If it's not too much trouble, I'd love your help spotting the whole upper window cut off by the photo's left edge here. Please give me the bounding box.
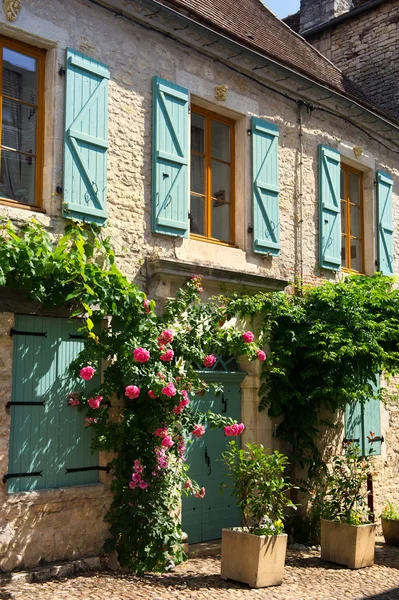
[0,36,45,206]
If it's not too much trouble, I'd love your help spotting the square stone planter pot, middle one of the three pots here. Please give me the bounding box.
[321,519,377,569]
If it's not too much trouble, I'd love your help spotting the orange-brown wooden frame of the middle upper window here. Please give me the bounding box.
[190,104,236,247]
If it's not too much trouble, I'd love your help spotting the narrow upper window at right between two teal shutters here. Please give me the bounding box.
[341,163,364,273]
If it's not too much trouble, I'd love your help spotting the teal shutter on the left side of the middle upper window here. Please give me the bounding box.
[152,77,189,237]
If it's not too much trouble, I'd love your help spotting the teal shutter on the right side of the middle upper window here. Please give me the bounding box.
[252,117,280,256]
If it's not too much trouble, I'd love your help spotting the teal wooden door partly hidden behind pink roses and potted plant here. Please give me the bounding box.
[182,381,241,544]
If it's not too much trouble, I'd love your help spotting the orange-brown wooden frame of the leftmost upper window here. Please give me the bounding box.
[0,35,46,212]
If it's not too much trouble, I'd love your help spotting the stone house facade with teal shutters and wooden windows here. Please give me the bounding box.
[0,0,399,571]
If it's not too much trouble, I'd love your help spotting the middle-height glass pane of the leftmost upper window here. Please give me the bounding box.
[1,99,37,154]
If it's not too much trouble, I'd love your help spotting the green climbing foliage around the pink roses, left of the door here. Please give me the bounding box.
[0,221,264,574]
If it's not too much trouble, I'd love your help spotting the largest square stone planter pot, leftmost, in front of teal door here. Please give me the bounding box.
[221,529,288,588]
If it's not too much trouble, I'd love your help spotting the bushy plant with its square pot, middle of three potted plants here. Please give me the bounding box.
[319,443,377,569]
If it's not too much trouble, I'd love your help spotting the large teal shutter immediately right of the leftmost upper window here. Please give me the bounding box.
[63,48,109,225]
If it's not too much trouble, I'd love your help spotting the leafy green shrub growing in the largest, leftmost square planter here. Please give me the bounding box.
[222,440,295,535]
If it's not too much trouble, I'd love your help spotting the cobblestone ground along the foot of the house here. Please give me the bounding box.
[0,543,399,600]
